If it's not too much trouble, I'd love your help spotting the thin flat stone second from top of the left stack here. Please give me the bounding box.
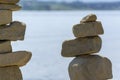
[0,4,21,11]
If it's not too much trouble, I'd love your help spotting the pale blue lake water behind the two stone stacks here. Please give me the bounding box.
[12,11,120,80]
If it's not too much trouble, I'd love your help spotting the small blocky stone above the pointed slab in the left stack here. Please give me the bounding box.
[0,41,12,54]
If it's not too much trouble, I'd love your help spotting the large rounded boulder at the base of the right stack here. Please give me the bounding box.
[69,55,113,80]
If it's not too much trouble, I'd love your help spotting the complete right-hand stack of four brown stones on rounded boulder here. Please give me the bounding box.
[61,14,113,80]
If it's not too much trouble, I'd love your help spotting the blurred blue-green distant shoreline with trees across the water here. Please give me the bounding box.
[20,0,120,10]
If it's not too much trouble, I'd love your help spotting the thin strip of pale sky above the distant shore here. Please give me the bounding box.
[39,0,120,2]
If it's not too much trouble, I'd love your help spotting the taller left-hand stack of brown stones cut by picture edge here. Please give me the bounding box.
[0,0,31,80]
